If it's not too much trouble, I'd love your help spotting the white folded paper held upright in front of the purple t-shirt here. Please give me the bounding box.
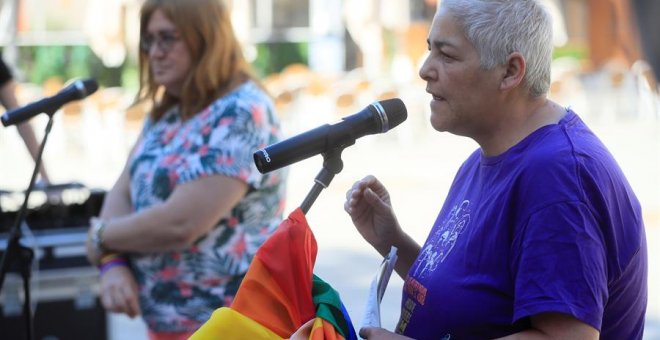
[360,246,397,328]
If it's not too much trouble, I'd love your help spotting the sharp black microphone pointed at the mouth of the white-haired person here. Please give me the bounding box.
[253,98,408,174]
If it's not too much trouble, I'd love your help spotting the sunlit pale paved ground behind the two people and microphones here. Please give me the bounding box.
[0,79,660,339]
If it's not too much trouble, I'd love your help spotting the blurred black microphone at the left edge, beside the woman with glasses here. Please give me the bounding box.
[2,79,99,126]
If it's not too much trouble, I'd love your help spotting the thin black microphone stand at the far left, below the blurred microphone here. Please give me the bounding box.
[0,114,55,340]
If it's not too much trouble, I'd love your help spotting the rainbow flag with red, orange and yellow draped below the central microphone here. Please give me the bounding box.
[190,208,357,340]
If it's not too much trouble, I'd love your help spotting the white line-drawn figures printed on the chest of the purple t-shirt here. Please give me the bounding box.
[413,200,470,278]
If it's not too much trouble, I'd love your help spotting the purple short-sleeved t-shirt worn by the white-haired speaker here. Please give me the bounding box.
[397,110,647,339]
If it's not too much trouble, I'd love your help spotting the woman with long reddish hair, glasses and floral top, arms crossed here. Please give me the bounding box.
[87,0,285,339]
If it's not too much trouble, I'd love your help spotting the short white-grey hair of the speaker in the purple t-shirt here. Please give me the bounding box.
[440,0,553,96]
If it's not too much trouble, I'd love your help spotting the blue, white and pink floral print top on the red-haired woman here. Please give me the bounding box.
[129,81,285,332]
